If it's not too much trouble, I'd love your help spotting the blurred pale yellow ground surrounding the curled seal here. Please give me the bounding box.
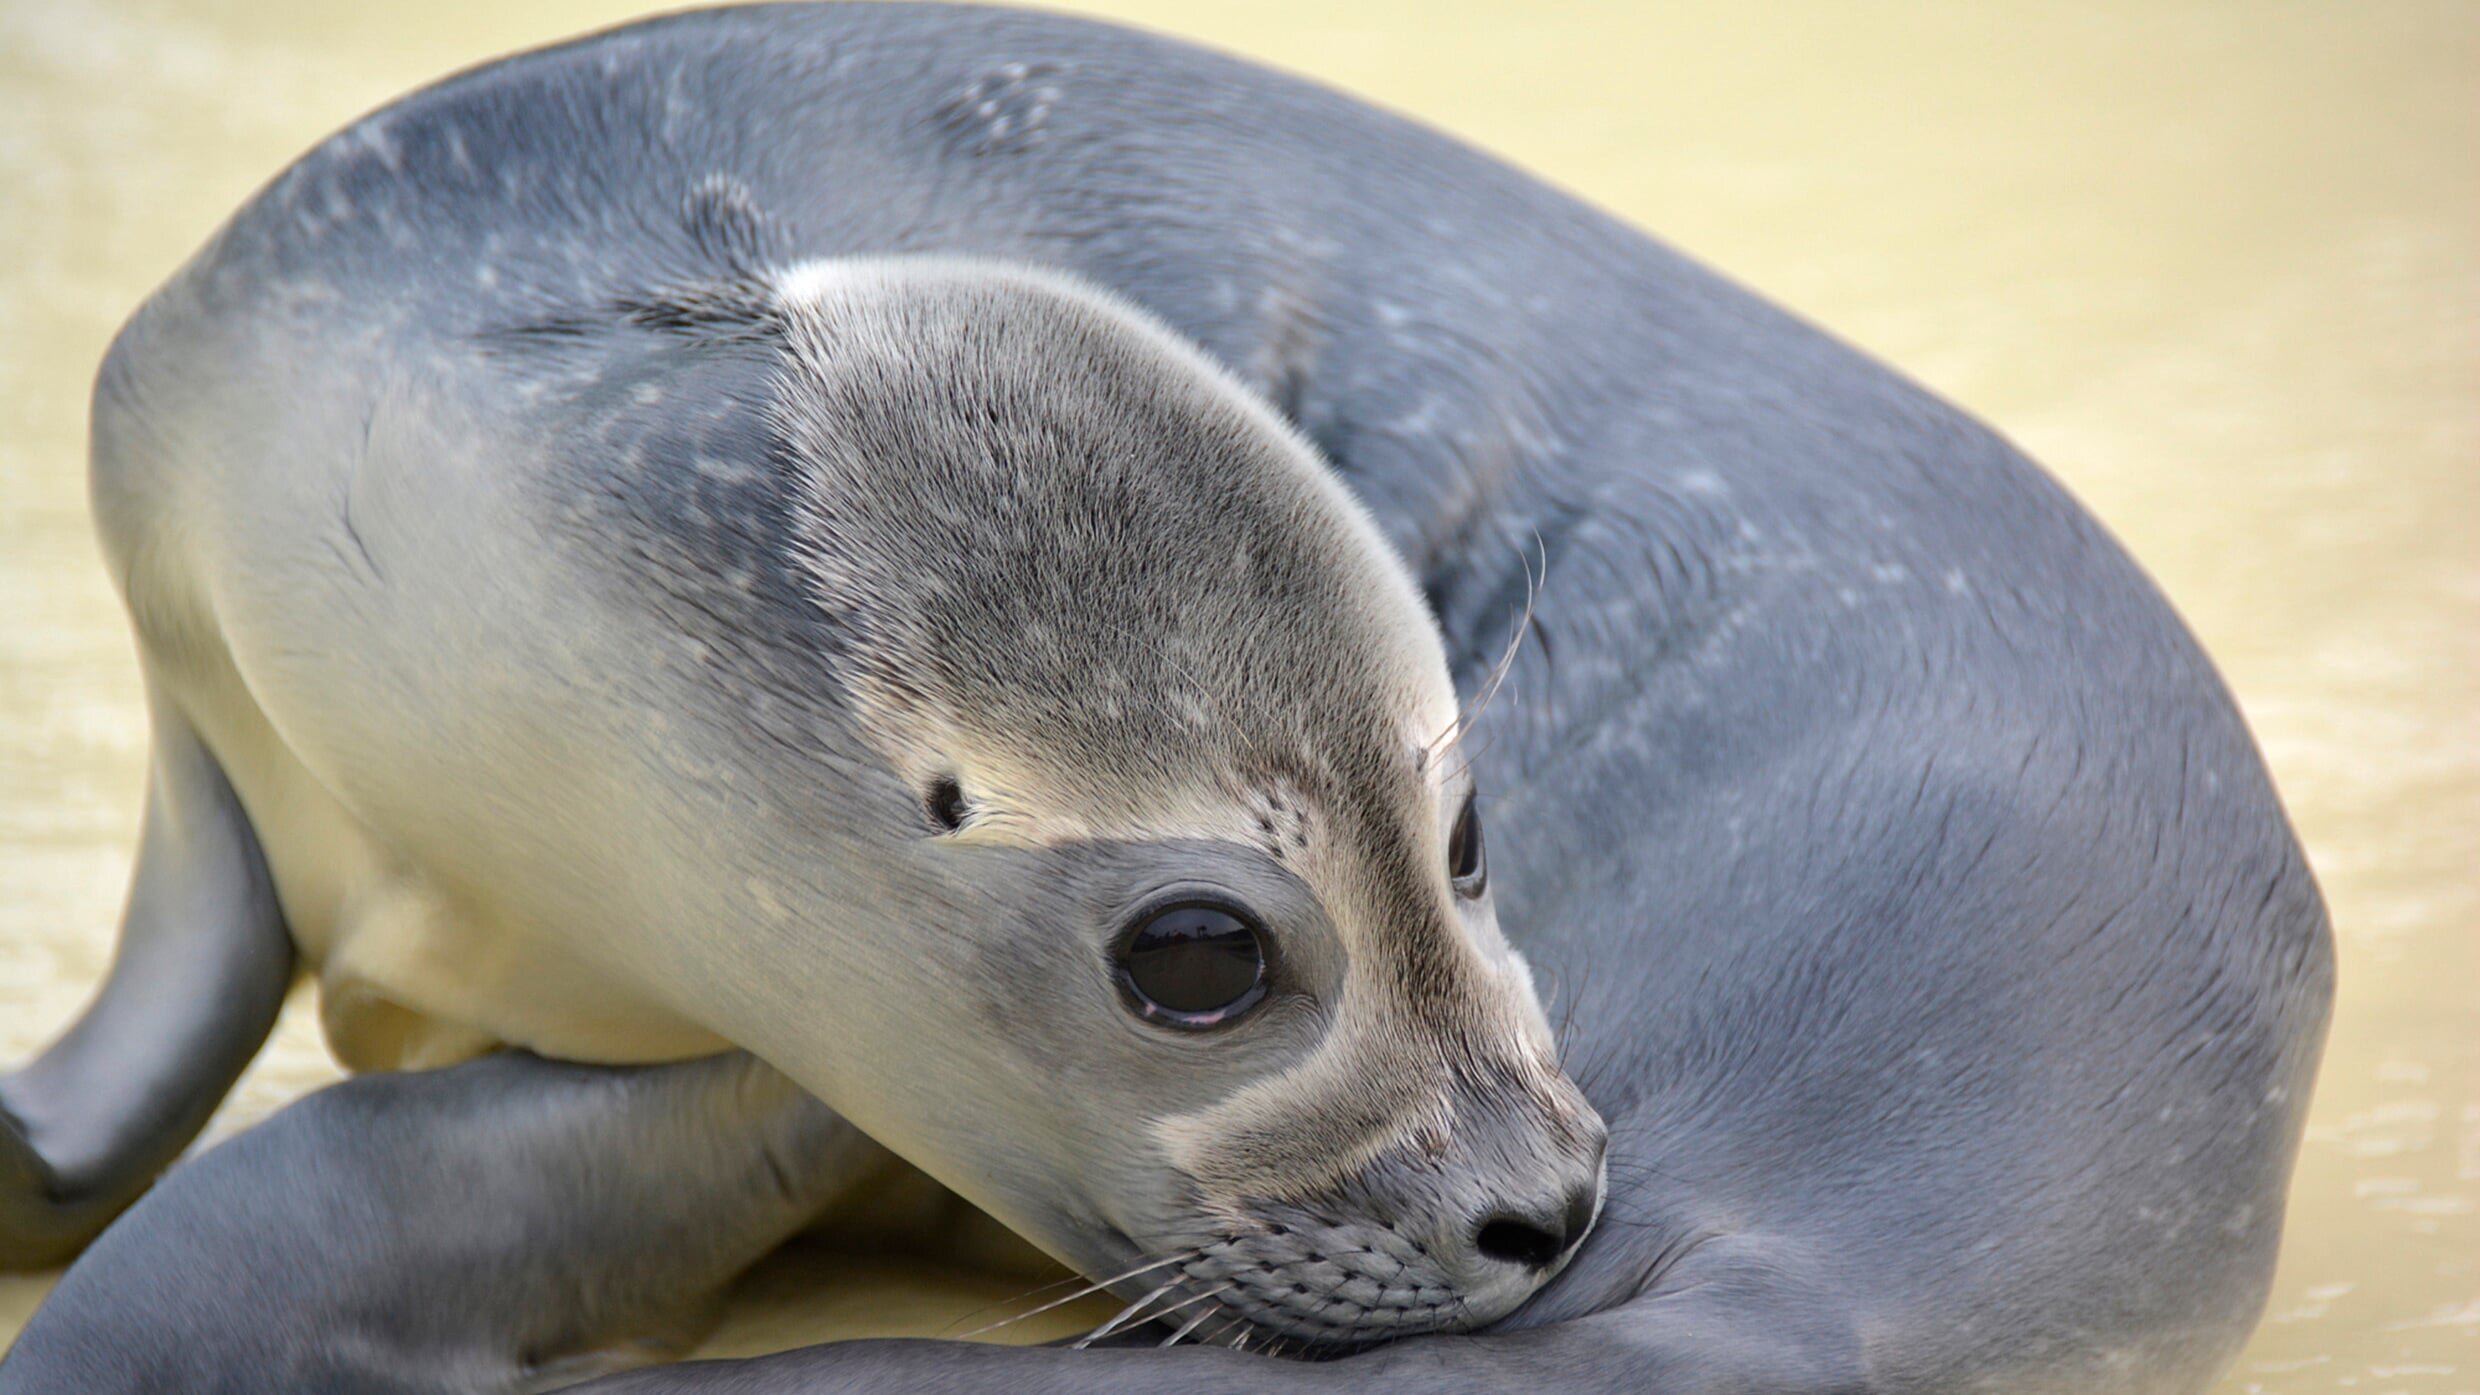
[0,0,2480,1395]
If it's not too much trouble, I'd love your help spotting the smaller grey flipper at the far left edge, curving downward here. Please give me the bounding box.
[0,695,293,1271]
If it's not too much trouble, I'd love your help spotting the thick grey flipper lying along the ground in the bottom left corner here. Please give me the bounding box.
[0,1052,888,1395]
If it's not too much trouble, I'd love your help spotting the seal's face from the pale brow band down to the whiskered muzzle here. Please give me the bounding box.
[942,709,1602,1343]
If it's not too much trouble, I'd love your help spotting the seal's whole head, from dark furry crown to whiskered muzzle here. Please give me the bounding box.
[774,261,1605,1343]
